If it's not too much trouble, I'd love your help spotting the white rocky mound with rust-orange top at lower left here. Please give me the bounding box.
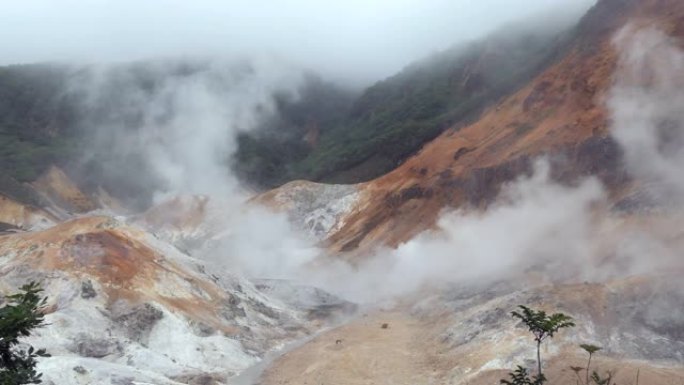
[0,217,326,385]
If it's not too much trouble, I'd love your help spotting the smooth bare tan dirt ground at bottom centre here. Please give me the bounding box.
[260,311,440,385]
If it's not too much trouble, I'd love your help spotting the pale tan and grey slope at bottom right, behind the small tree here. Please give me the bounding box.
[262,275,684,385]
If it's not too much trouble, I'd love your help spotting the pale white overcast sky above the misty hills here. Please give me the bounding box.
[0,0,596,81]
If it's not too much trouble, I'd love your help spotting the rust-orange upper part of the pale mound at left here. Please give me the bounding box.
[0,216,300,335]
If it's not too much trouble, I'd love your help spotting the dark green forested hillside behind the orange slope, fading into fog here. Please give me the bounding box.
[234,23,566,187]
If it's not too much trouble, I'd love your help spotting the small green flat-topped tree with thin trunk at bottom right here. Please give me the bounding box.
[511,305,575,379]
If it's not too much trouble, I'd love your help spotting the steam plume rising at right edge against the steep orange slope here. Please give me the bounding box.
[608,26,684,206]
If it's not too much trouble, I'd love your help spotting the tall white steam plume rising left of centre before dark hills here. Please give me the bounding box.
[70,57,328,278]
